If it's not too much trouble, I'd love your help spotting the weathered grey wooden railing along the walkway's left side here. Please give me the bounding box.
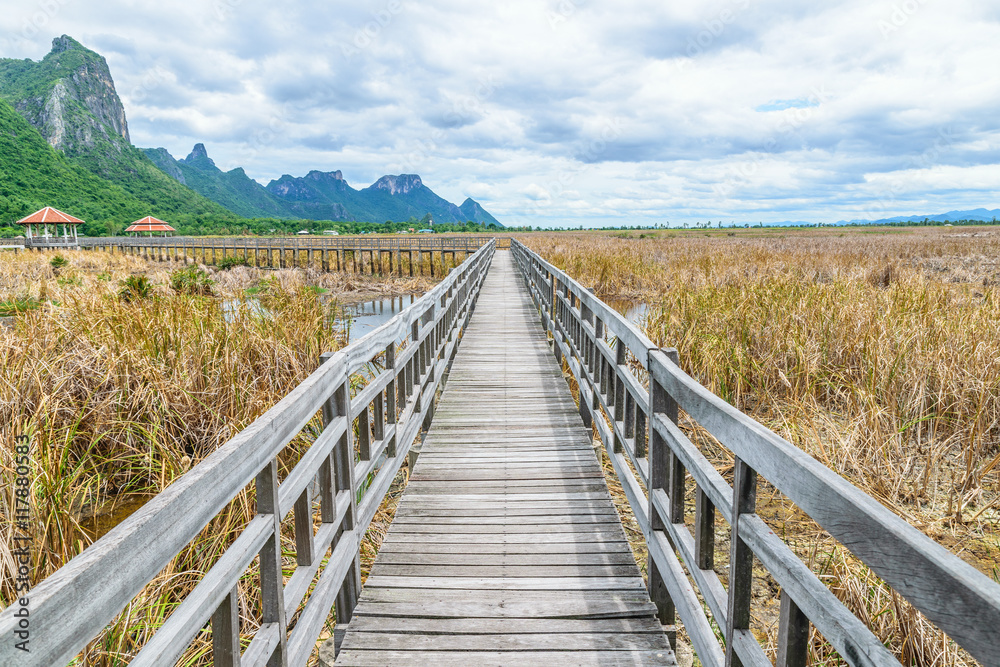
[0,242,494,667]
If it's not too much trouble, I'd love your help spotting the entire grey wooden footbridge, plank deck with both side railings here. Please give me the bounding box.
[0,241,1000,667]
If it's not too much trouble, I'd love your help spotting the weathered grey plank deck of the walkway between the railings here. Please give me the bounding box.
[337,252,675,665]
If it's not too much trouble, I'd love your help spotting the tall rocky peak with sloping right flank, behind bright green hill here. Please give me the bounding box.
[0,35,235,219]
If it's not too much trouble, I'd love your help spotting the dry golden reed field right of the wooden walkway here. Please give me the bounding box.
[522,228,1000,665]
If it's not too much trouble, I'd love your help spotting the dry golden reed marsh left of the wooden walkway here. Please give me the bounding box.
[0,251,431,665]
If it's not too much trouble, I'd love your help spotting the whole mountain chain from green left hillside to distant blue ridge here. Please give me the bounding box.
[0,35,502,233]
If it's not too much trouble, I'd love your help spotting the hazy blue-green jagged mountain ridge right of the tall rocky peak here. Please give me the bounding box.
[144,144,502,226]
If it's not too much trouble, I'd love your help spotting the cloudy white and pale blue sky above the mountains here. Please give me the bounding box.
[0,0,1000,226]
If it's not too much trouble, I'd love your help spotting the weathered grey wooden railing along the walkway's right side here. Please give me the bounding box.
[512,240,1000,667]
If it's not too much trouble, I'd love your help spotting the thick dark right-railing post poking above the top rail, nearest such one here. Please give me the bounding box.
[648,343,680,650]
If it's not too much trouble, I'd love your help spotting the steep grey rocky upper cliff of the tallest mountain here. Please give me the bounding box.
[0,35,131,155]
